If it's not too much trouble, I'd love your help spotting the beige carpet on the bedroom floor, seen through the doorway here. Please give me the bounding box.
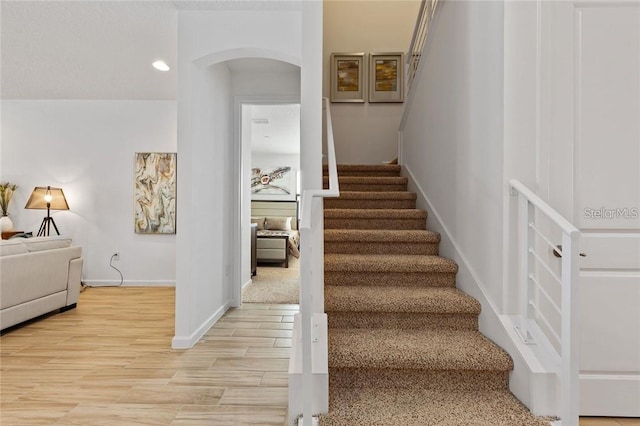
[242,256,300,304]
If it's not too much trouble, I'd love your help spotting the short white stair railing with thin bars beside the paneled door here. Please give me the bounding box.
[509,180,580,426]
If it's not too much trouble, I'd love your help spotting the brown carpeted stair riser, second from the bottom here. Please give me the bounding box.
[327,311,478,330]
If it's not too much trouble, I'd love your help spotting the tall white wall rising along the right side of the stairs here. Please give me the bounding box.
[401,1,555,415]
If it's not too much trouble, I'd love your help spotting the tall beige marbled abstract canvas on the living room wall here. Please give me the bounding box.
[133,152,177,234]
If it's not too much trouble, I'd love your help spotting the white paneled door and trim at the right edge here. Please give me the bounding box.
[543,1,640,417]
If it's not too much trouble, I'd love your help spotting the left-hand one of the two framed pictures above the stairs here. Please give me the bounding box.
[331,53,367,102]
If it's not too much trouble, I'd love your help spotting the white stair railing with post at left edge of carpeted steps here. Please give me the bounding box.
[298,98,340,426]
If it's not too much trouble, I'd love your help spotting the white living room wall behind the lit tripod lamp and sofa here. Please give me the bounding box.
[0,100,176,285]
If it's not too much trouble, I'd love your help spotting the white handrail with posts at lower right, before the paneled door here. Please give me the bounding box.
[509,180,580,426]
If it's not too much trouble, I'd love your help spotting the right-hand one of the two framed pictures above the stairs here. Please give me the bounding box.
[369,52,404,102]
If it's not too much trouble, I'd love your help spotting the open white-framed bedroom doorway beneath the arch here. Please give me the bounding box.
[233,96,300,306]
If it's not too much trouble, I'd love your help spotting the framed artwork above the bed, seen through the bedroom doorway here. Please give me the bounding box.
[251,166,297,201]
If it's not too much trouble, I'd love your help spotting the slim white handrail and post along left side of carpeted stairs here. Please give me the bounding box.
[298,98,340,426]
